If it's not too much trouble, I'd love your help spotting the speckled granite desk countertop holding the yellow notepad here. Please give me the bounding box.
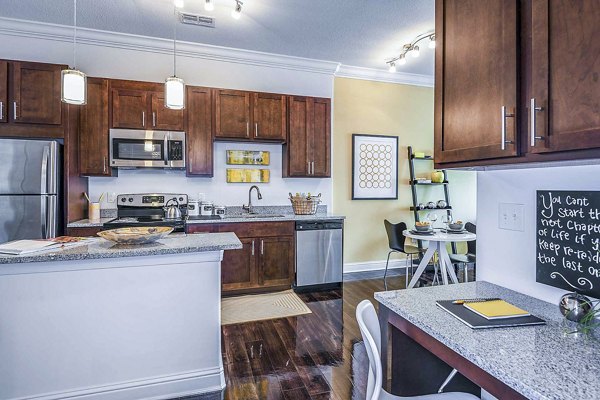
[375,282,600,400]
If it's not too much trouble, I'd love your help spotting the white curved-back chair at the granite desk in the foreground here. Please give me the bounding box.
[356,300,479,400]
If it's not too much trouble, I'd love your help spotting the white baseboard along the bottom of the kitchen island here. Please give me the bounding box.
[18,368,225,400]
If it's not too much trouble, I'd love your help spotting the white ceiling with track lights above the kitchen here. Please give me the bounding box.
[0,0,434,75]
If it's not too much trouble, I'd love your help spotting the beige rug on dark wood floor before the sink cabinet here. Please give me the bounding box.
[221,290,312,325]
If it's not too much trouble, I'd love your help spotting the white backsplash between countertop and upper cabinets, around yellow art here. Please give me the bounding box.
[89,143,332,209]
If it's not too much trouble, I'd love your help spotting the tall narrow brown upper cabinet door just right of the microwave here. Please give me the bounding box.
[185,86,213,176]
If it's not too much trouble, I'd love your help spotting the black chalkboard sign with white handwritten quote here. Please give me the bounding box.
[536,190,600,298]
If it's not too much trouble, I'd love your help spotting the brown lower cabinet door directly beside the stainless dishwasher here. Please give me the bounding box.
[258,236,294,286]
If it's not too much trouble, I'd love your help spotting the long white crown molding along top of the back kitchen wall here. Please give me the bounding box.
[0,17,340,75]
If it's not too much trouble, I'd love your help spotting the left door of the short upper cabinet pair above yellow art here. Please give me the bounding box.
[215,90,251,140]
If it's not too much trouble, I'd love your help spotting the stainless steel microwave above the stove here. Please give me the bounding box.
[110,129,185,169]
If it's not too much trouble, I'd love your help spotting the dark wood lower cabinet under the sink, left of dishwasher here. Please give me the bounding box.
[186,222,295,295]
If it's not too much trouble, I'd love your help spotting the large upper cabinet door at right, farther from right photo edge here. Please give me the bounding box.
[434,0,520,163]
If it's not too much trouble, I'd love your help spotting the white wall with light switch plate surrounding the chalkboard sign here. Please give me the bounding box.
[477,165,600,303]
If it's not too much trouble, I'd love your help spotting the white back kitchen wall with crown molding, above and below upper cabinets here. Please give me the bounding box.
[0,19,337,208]
